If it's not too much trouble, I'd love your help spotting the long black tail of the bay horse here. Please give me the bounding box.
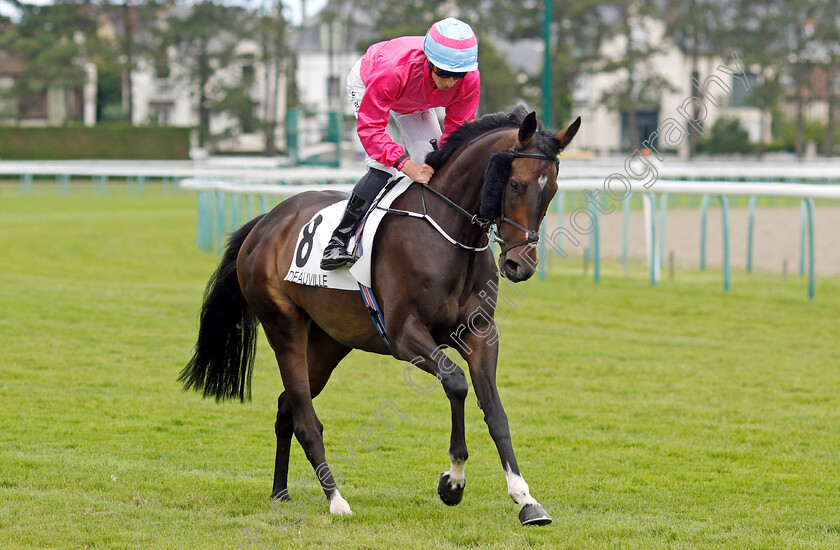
[178,216,262,401]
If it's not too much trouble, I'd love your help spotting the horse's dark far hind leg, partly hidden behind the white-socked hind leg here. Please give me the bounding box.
[271,323,350,500]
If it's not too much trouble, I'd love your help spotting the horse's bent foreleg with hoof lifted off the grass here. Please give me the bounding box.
[394,317,469,506]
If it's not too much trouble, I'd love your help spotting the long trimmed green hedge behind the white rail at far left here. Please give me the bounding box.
[0,125,191,160]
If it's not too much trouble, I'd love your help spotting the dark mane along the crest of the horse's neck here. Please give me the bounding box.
[426,105,563,170]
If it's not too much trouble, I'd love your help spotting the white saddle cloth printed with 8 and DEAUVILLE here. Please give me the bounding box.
[284,178,412,292]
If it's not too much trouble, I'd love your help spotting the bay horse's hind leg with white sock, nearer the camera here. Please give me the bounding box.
[258,302,350,514]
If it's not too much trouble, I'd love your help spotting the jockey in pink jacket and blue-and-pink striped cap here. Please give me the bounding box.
[321,17,481,271]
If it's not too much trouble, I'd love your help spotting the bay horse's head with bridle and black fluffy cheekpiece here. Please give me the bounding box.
[482,112,580,282]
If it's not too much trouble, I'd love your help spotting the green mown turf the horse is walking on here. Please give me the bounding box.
[0,182,840,549]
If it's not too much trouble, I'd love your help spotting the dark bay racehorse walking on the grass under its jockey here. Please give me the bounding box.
[179,107,580,525]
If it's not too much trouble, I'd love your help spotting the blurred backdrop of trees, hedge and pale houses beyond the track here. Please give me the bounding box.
[0,0,840,164]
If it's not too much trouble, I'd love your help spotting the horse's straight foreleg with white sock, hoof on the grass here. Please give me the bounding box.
[465,335,551,525]
